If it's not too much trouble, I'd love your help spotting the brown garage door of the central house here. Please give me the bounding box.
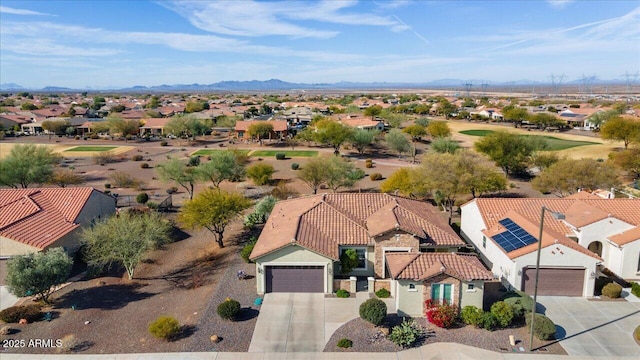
[265,266,324,292]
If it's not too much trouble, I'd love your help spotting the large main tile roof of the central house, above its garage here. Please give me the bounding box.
[251,193,464,260]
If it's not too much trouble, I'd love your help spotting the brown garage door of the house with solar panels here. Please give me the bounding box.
[522,267,585,296]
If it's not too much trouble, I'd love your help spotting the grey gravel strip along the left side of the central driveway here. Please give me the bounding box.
[184,255,260,352]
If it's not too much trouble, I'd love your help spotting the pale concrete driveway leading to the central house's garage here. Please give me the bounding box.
[249,293,395,352]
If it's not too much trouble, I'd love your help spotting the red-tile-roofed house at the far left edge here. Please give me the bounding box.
[0,187,116,257]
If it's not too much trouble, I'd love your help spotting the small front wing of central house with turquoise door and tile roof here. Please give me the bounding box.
[386,253,494,316]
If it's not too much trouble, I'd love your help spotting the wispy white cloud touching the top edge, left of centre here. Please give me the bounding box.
[159,0,406,38]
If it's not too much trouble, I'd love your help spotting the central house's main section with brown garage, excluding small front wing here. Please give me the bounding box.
[250,193,466,293]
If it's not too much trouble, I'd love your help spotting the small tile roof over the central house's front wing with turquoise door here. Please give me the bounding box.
[386,253,493,281]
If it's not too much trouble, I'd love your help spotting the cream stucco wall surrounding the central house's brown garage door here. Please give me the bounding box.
[256,244,333,294]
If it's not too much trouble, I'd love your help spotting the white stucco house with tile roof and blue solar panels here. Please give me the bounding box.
[461,192,640,297]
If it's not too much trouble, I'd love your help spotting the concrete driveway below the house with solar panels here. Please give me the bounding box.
[538,296,640,359]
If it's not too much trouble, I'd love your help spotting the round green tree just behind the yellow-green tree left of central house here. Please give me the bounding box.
[196,150,246,188]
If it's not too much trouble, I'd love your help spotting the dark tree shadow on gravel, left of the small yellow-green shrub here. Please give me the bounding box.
[55,284,156,310]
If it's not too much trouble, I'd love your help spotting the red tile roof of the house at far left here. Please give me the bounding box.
[0,187,96,249]
